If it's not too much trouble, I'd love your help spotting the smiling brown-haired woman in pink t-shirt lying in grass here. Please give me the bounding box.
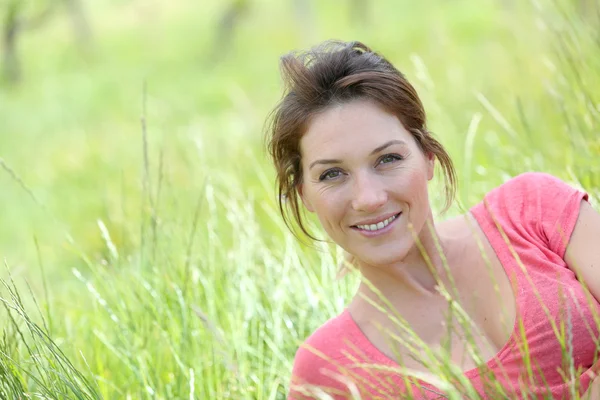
[269,42,600,399]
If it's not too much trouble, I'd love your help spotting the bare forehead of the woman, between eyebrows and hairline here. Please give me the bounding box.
[300,100,412,159]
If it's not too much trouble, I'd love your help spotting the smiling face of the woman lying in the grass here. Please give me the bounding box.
[299,100,434,266]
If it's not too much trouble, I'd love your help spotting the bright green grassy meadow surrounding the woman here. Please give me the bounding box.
[0,0,600,399]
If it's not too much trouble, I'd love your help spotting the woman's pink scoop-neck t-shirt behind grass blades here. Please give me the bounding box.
[288,173,600,400]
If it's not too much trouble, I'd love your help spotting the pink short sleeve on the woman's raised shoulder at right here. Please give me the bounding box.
[486,172,588,259]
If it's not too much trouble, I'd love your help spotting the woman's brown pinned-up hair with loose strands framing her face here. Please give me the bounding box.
[267,41,456,239]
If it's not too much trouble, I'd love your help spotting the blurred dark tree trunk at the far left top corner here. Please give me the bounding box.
[2,0,21,83]
